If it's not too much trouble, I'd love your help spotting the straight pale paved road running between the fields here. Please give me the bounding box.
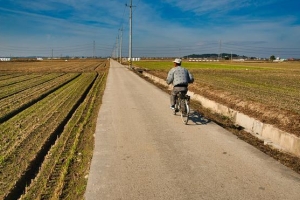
[85,61,300,200]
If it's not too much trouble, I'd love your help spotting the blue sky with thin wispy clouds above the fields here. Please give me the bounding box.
[0,0,300,58]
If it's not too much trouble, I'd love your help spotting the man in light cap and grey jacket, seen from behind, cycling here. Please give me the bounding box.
[166,58,194,109]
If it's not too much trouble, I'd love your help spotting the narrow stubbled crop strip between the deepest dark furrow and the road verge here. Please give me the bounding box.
[21,71,106,199]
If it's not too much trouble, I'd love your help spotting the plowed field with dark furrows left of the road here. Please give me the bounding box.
[0,60,109,199]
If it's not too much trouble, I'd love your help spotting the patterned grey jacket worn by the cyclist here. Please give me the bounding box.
[166,66,194,86]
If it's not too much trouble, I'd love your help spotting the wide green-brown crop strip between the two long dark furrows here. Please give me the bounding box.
[0,73,96,197]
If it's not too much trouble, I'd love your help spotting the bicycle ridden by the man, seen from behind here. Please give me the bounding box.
[174,92,190,124]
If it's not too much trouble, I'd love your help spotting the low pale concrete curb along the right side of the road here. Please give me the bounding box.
[142,71,300,157]
